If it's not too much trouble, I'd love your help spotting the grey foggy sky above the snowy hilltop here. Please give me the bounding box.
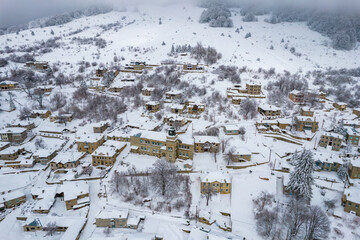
[0,0,360,28]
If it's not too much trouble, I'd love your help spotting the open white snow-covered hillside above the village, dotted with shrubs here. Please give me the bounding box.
[0,5,360,72]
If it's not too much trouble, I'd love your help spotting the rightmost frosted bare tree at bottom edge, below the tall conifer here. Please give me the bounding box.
[304,206,330,240]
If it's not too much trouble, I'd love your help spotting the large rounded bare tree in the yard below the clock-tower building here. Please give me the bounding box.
[150,159,179,196]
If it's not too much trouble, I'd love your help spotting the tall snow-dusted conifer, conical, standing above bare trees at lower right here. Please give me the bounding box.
[287,149,314,201]
